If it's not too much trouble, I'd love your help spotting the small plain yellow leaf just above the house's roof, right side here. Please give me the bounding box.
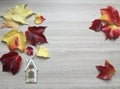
[36,46,50,58]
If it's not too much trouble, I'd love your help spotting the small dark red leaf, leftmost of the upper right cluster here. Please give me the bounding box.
[89,19,102,31]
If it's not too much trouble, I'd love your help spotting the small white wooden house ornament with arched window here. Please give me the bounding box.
[25,59,38,83]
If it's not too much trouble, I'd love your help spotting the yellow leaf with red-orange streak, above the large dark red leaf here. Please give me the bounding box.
[2,30,26,51]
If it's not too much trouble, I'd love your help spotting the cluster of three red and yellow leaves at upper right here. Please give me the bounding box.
[89,6,120,40]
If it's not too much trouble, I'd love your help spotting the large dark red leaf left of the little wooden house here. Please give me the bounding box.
[0,52,22,75]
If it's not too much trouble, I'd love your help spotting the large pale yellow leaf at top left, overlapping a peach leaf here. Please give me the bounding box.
[3,4,33,24]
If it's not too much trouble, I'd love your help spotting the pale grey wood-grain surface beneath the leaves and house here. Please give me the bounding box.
[0,0,120,89]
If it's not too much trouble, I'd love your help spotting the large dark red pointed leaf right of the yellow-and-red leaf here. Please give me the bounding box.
[25,26,47,45]
